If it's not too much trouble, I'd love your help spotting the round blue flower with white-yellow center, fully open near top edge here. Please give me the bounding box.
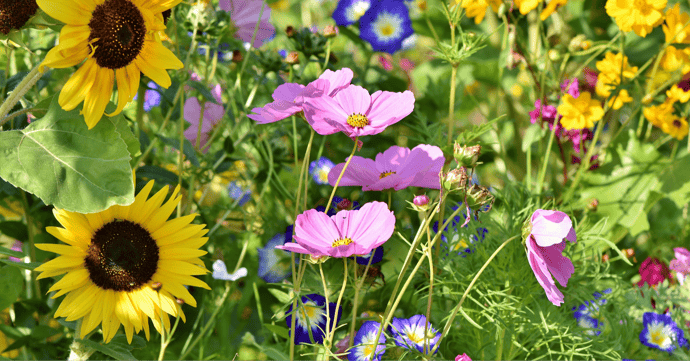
[359,0,414,54]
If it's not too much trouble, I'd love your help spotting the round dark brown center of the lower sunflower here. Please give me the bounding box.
[84,218,159,291]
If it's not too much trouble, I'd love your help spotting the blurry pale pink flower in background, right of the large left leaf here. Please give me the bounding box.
[184,85,225,153]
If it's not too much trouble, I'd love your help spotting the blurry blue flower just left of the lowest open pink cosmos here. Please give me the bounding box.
[258,226,293,283]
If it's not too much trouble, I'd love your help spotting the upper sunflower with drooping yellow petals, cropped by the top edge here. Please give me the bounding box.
[37,0,183,129]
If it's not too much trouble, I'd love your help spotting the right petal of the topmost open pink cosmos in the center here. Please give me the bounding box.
[367,90,414,128]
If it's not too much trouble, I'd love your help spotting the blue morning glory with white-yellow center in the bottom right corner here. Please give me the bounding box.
[640,312,688,353]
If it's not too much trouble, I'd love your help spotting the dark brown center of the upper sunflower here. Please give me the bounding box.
[89,0,146,69]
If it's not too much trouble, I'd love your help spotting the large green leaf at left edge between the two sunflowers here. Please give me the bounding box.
[0,97,134,213]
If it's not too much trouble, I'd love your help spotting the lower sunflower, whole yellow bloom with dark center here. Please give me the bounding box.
[36,181,209,342]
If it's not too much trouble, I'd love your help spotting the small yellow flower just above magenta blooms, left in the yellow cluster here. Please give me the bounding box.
[557,92,604,130]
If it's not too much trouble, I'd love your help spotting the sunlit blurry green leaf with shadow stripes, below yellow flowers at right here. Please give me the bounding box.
[581,130,668,236]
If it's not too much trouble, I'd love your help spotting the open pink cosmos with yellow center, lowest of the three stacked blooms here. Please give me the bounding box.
[276,202,395,258]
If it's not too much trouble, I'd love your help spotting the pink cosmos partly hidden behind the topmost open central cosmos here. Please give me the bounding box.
[247,68,354,124]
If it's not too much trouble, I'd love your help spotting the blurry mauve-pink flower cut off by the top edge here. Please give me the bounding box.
[218,0,276,48]
